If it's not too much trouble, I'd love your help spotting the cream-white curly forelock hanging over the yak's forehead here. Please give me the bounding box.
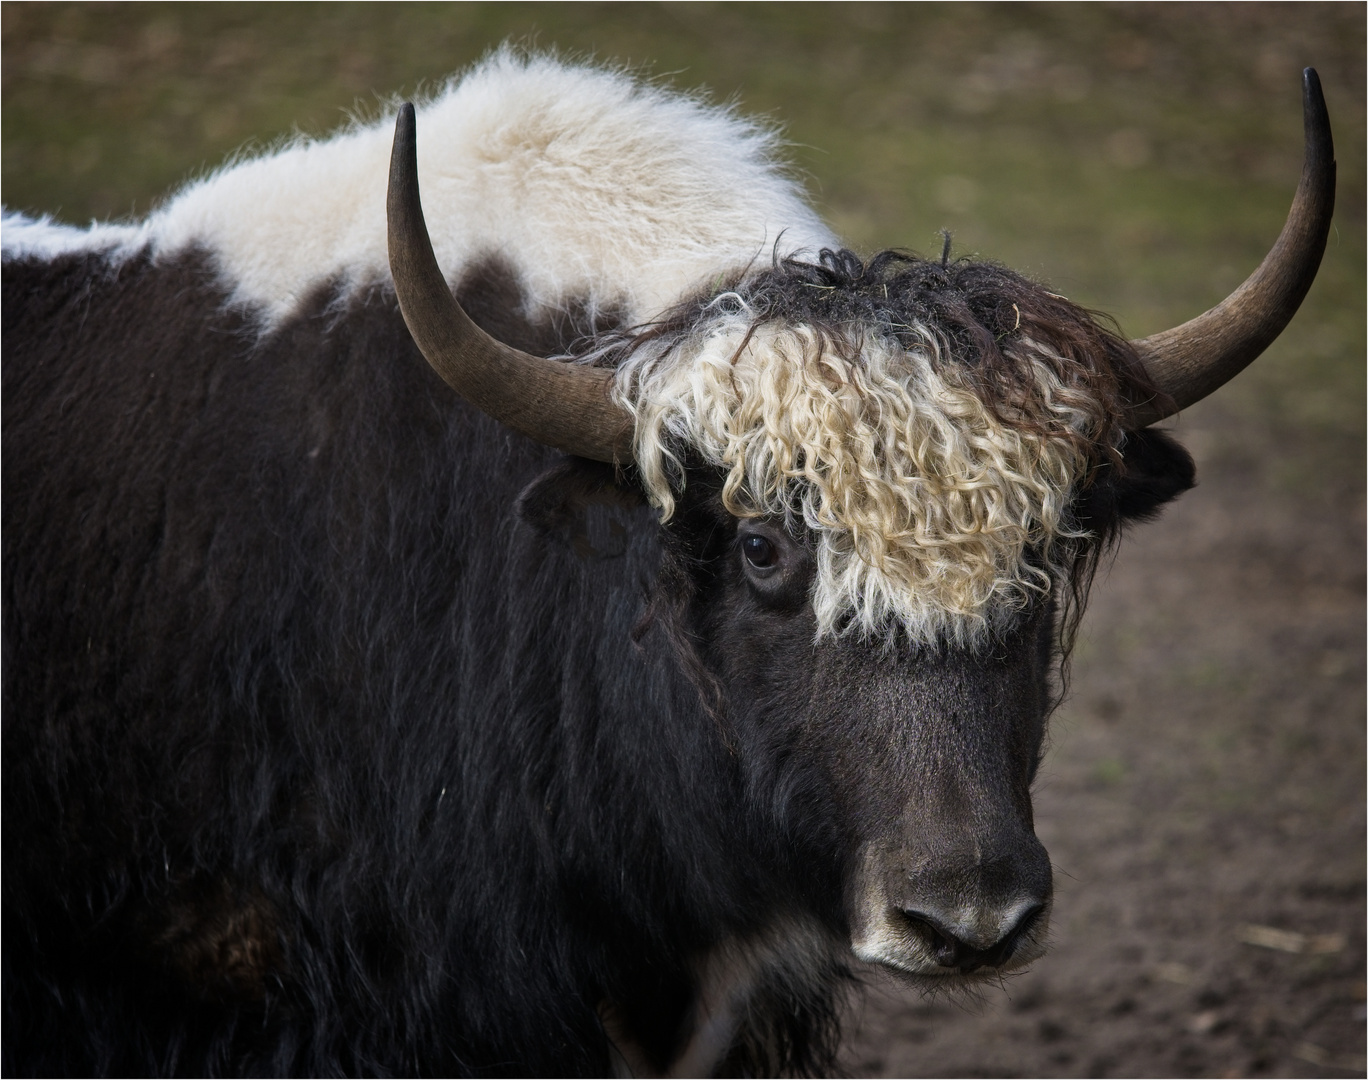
[616,309,1094,646]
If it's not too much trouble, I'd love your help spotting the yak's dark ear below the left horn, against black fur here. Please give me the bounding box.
[517,457,647,560]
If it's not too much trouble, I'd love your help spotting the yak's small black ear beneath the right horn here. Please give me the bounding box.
[1077,427,1197,535]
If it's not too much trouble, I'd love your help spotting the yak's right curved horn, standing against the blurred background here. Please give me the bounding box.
[1126,67,1335,430]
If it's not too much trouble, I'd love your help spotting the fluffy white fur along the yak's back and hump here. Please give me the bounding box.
[3,49,836,324]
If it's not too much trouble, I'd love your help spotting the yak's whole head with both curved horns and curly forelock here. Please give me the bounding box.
[389,65,1334,981]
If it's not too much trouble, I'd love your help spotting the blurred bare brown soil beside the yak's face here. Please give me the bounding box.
[844,387,1365,1076]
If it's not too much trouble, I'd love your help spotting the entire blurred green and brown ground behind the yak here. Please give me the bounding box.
[0,3,1365,1076]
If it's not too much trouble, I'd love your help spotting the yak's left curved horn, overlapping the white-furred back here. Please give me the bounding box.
[386,103,632,463]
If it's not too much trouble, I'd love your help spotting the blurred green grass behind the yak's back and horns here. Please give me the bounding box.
[0,3,1365,479]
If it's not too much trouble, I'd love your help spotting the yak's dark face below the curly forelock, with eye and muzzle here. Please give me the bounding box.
[648,470,1055,976]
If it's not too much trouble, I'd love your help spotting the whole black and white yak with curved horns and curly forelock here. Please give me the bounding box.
[3,51,1334,1076]
